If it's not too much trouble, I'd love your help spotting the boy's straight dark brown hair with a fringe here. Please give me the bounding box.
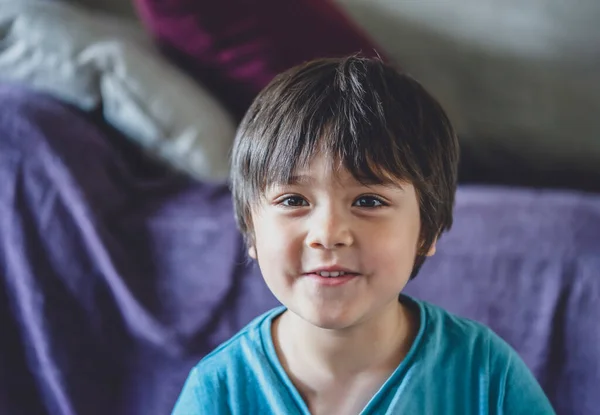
[231,56,458,278]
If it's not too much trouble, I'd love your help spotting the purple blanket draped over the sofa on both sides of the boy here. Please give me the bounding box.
[0,86,600,415]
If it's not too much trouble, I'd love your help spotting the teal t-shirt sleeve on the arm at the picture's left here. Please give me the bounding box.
[171,368,230,415]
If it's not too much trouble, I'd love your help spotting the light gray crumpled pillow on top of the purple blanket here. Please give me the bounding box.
[0,0,235,181]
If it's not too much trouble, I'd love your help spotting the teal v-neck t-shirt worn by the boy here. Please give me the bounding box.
[173,296,554,415]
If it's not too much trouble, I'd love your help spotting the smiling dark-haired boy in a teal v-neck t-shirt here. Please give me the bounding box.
[173,57,554,415]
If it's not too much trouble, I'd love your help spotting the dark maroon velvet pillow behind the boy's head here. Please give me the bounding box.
[135,0,382,118]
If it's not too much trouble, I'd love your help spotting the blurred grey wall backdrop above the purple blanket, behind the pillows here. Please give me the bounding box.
[78,0,600,190]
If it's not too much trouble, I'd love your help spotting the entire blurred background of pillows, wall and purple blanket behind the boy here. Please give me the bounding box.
[0,0,600,415]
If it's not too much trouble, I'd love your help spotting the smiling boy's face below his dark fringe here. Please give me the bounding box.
[250,157,434,329]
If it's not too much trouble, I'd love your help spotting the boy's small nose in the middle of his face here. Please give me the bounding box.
[306,206,354,249]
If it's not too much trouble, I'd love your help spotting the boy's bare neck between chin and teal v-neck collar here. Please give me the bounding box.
[276,302,415,379]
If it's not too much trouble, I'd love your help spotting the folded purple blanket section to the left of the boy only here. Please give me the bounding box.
[0,85,275,415]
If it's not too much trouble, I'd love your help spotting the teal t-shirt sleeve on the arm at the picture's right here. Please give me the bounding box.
[490,335,555,415]
